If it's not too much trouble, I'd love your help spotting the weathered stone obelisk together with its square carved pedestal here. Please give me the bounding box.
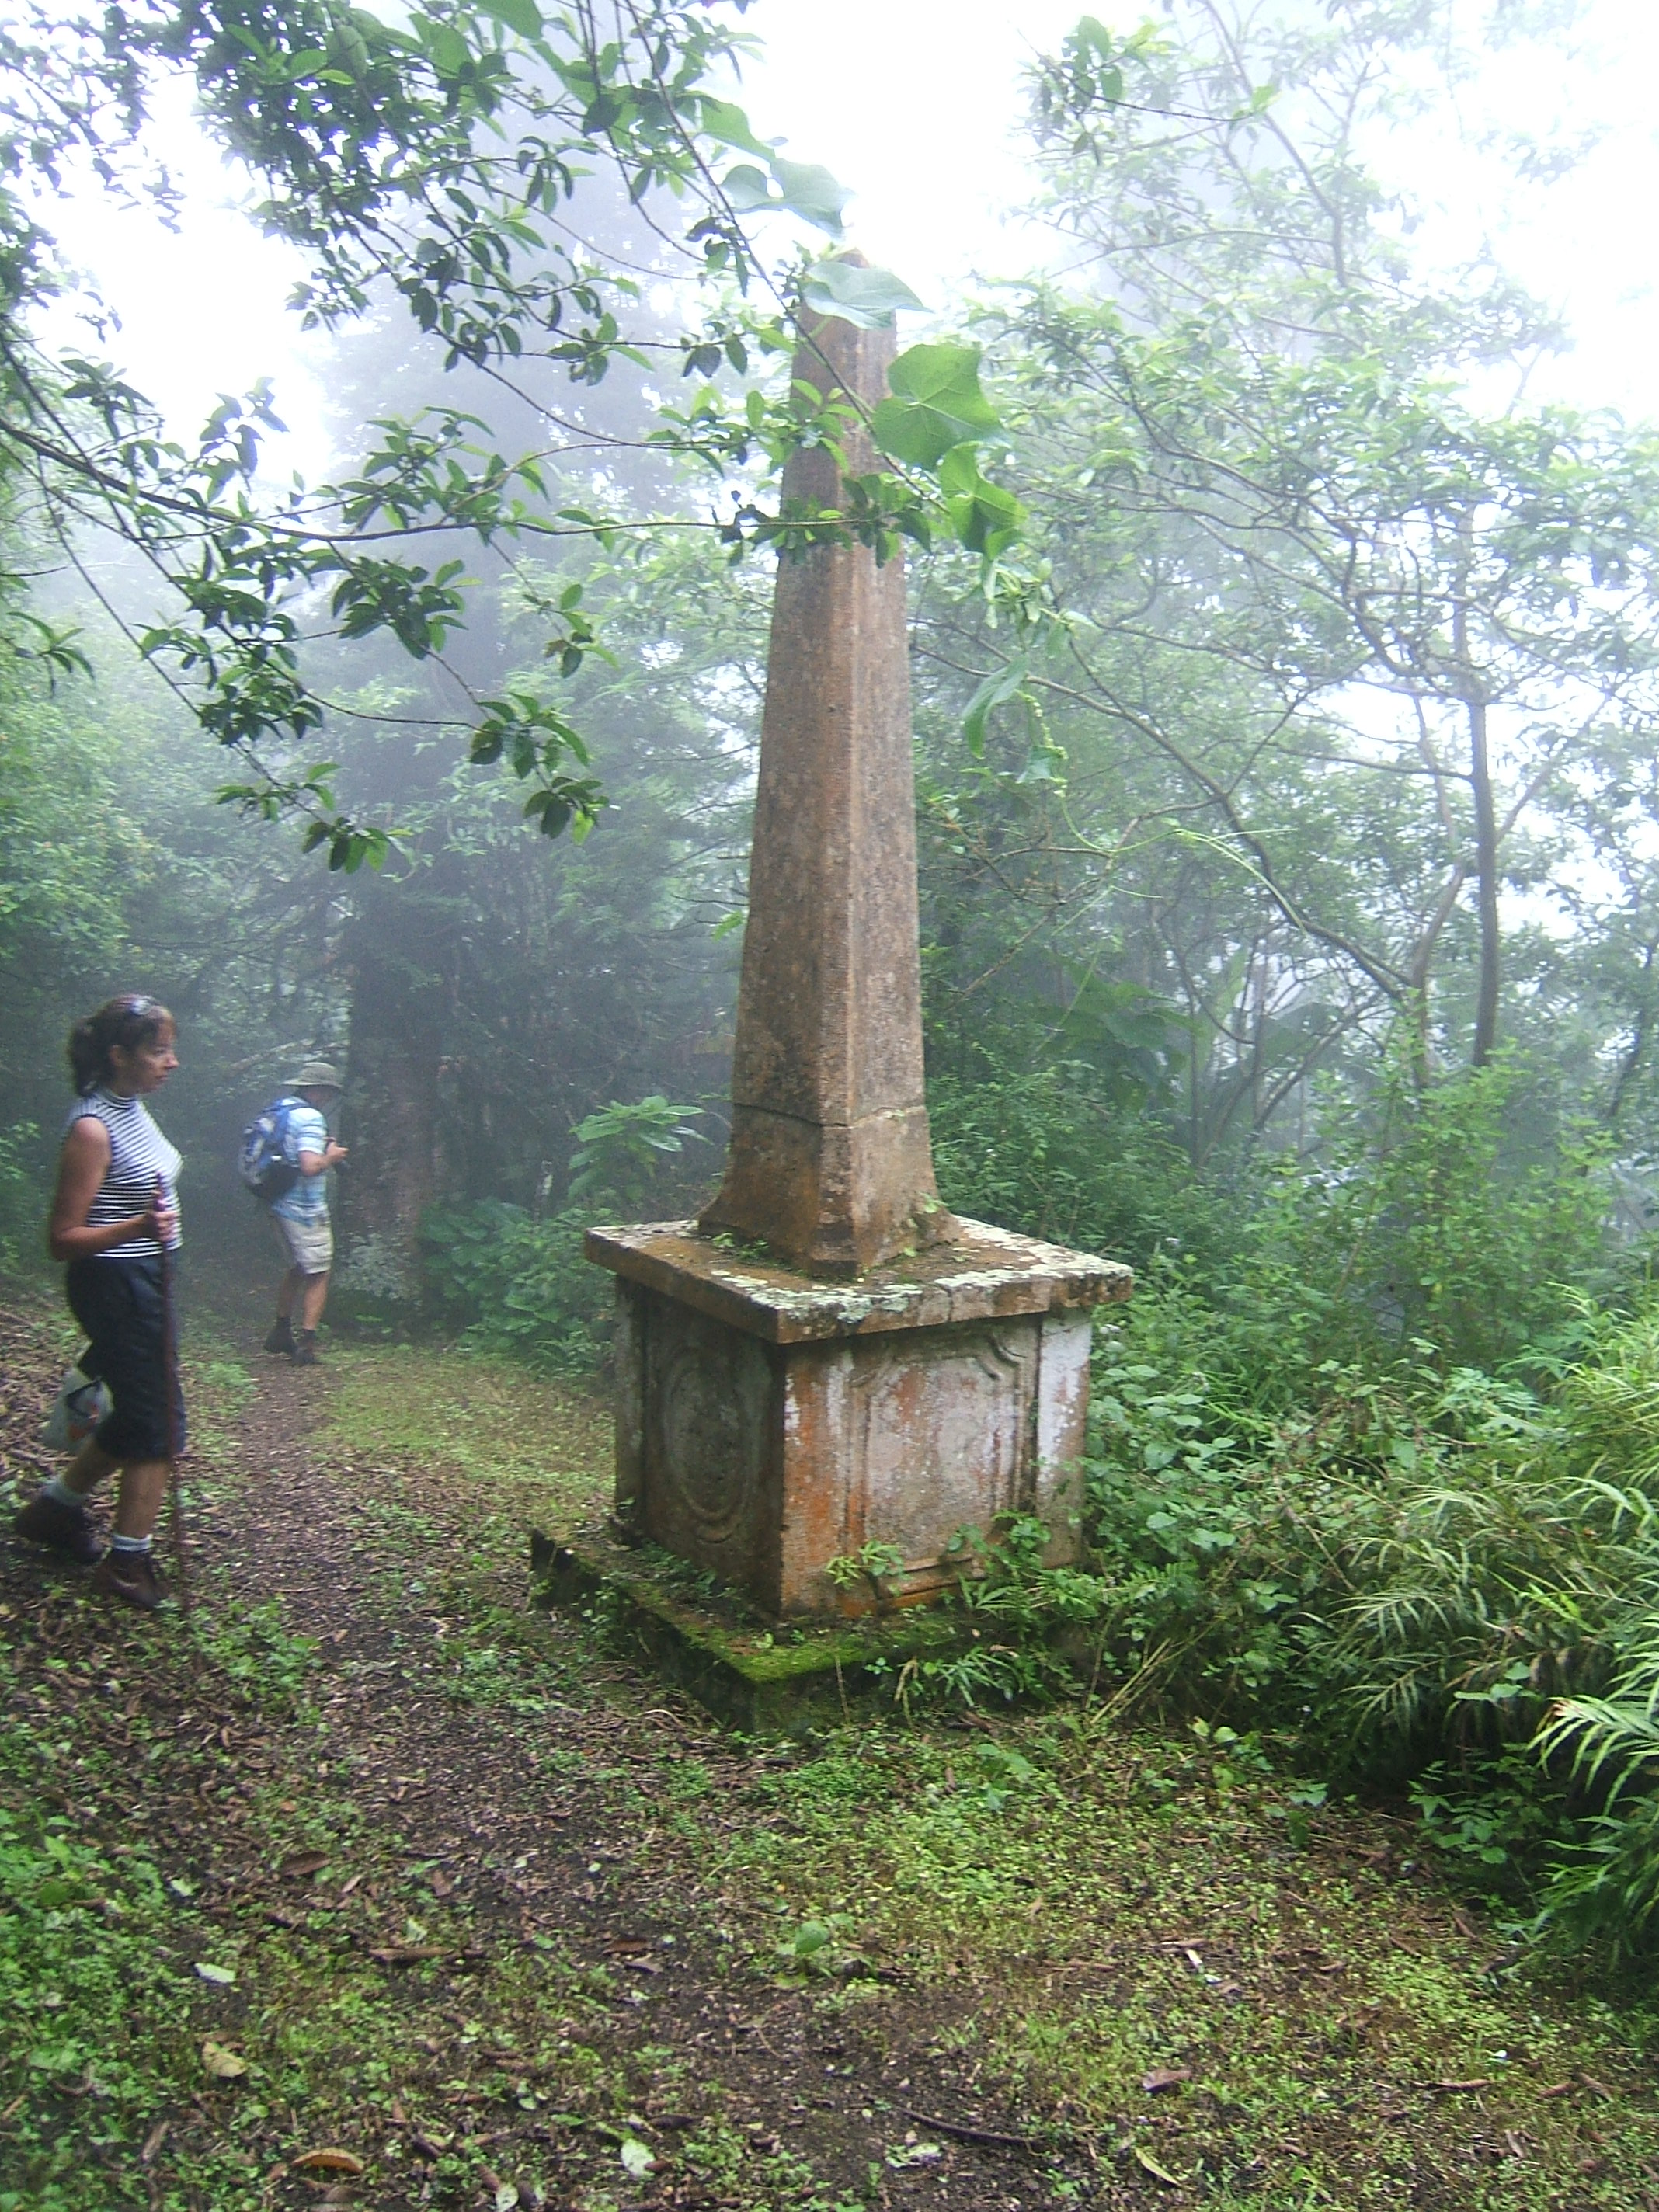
[586,303,1130,1619]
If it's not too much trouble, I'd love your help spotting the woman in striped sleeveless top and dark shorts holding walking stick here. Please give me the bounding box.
[16,993,183,1612]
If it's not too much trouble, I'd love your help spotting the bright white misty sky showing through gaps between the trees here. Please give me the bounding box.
[32,0,1659,475]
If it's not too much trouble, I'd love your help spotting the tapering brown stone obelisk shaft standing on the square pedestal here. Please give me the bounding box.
[701,318,942,1274]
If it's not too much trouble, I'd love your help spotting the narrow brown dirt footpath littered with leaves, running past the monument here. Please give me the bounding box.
[235,1362,1031,2207]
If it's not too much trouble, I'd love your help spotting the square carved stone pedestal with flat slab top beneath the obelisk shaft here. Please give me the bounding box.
[586,1221,1132,1619]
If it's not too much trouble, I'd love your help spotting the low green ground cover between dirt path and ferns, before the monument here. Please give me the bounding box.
[710,1708,1659,2212]
